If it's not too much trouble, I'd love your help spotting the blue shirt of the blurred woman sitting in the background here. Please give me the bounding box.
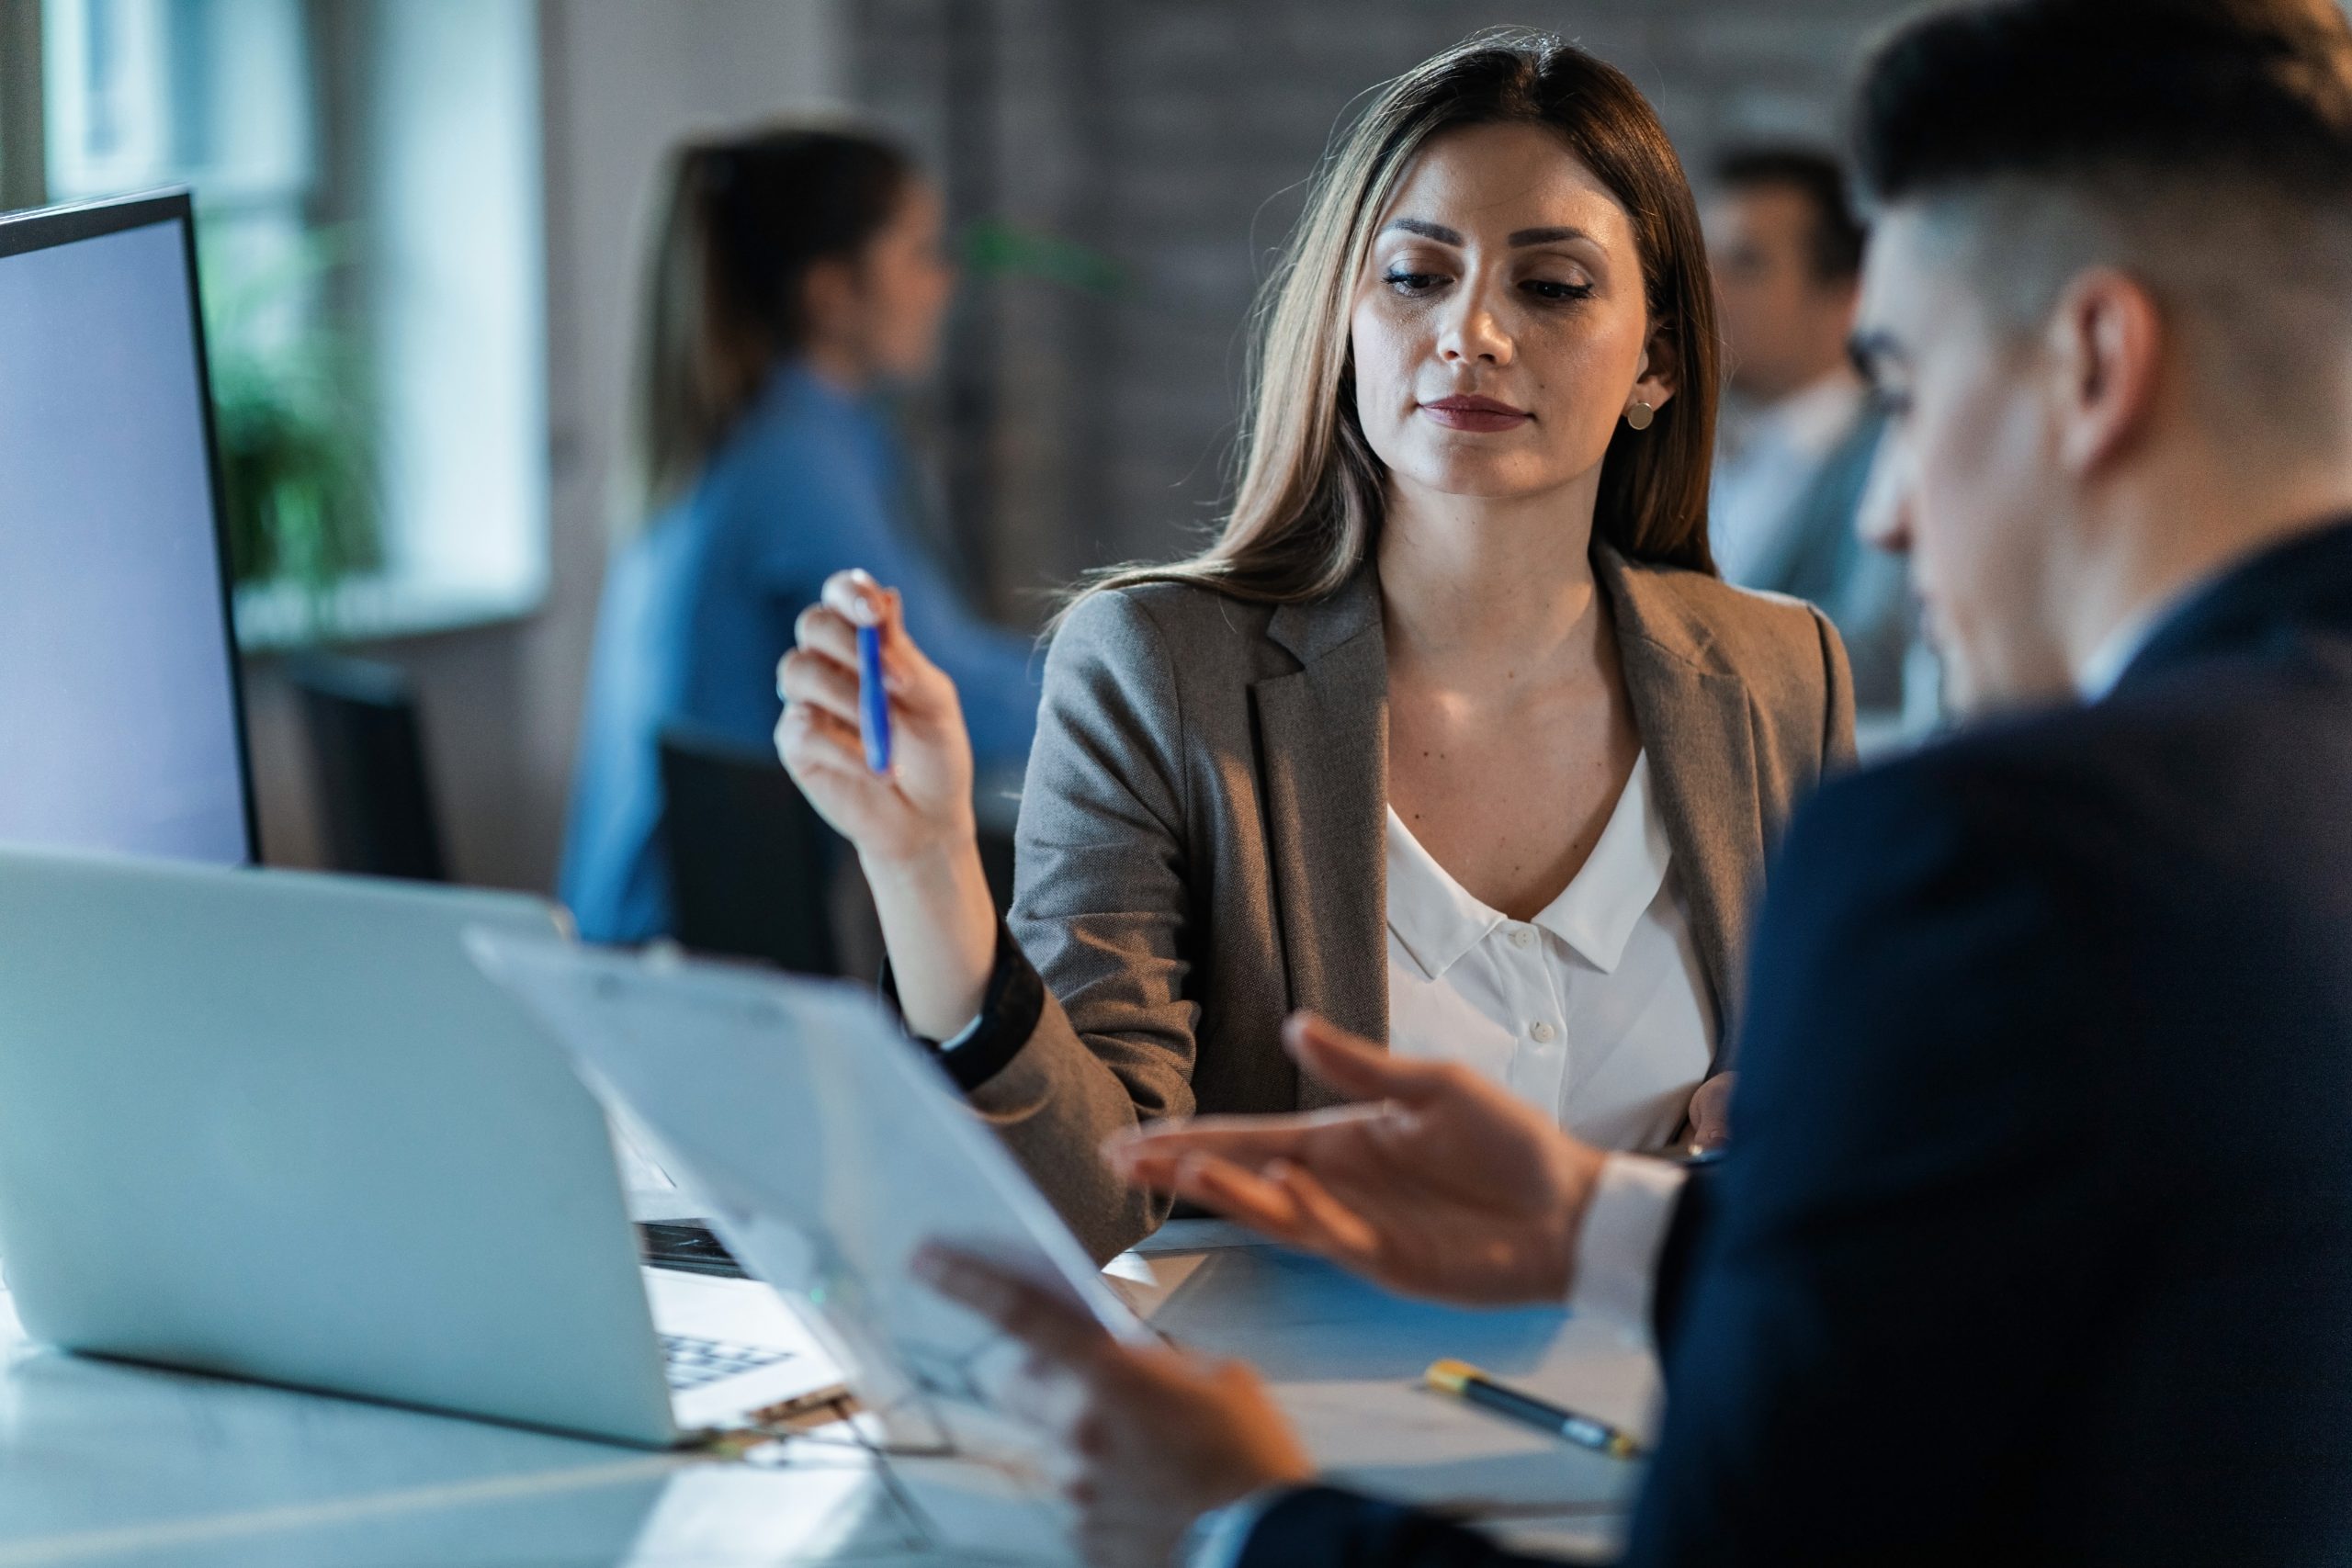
[560,365,1037,942]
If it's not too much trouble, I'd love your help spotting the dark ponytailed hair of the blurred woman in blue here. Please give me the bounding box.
[630,125,915,522]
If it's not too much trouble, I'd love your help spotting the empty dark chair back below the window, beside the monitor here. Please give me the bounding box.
[285,653,449,882]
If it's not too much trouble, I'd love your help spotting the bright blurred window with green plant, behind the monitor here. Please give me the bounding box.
[37,0,548,647]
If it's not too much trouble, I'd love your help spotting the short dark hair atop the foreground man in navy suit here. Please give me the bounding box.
[1856,0,2352,202]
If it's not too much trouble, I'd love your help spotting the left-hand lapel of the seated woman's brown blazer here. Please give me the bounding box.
[1251,569,1387,1110]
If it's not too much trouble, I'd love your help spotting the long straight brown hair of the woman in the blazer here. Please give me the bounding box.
[1091,30,1719,602]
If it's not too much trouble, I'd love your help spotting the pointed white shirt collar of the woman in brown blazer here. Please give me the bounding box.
[1387,752,1672,980]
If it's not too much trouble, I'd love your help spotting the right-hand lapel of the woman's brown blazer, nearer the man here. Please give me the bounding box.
[1592,546,1764,1069]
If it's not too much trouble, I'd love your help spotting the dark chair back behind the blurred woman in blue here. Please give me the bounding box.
[661,727,842,976]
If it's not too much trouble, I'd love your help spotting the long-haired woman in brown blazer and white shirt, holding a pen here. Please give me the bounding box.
[776,38,1853,1256]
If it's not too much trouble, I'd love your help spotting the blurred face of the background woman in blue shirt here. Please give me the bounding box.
[809,179,955,381]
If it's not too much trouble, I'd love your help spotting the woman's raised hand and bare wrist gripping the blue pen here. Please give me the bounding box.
[776,571,997,1039]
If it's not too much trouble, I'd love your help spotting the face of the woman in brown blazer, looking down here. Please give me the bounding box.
[1350,125,1672,499]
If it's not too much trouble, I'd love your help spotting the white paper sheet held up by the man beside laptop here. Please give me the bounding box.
[468,931,1148,1448]
